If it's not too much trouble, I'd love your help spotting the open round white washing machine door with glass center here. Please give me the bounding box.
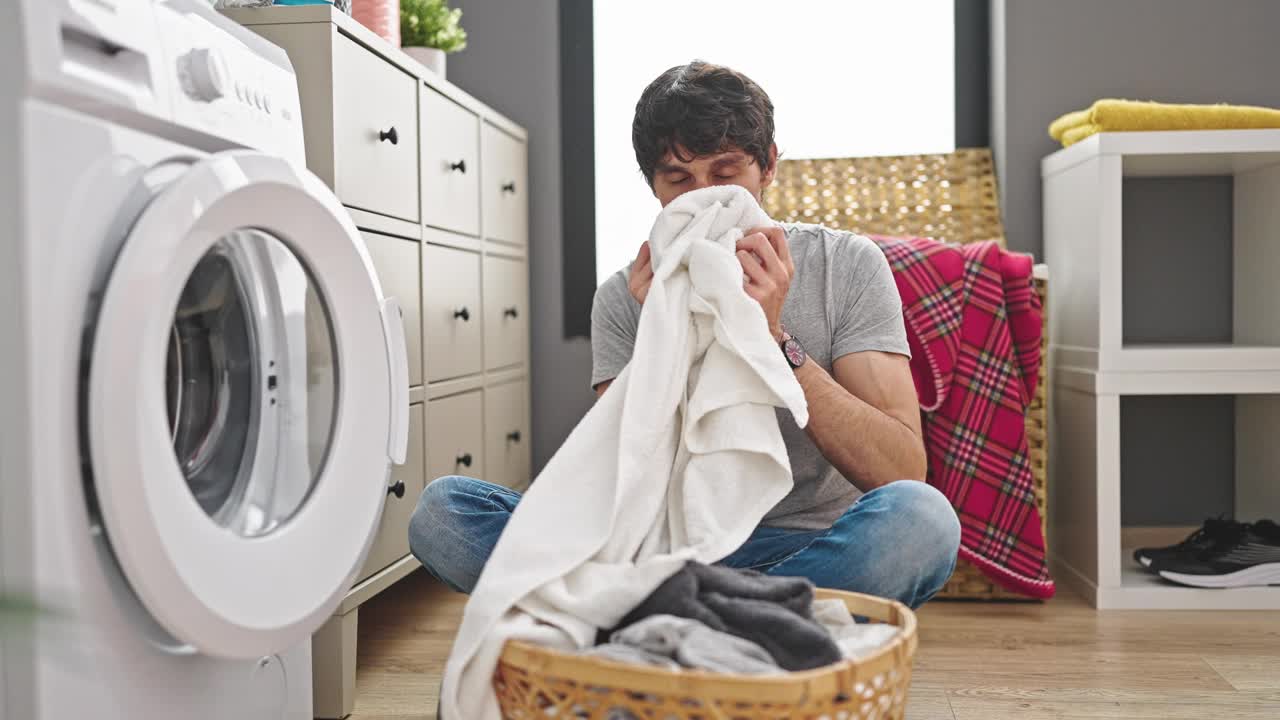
[84,152,408,659]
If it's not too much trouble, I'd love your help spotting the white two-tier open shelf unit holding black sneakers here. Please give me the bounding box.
[1041,129,1280,610]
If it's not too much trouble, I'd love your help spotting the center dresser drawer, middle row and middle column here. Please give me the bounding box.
[422,245,484,382]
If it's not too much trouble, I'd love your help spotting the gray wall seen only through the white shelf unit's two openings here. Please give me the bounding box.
[1120,177,1235,517]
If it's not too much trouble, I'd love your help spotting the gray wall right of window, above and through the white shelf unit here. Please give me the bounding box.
[991,0,1280,525]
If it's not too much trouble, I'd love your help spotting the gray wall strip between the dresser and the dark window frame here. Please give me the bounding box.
[448,0,595,474]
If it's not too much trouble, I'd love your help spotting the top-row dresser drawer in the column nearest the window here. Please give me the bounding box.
[483,124,527,246]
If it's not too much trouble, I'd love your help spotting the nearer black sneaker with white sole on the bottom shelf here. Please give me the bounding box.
[1152,520,1280,588]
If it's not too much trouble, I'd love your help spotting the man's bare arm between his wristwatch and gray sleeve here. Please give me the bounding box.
[796,351,927,492]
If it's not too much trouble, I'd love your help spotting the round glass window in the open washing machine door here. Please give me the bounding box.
[165,229,337,537]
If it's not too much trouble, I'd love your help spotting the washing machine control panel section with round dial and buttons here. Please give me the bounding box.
[156,0,306,163]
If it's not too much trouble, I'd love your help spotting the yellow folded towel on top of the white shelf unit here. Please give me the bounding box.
[1048,100,1280,147]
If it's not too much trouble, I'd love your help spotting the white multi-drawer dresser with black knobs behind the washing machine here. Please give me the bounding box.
[227,5,531,717]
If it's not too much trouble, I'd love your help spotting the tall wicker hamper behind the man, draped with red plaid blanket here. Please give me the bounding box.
[764,147,1048,600]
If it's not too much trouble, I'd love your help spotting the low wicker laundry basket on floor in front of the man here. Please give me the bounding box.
[493,589,916,720]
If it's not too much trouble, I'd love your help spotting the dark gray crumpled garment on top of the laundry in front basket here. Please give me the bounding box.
[608,562,844,670]
